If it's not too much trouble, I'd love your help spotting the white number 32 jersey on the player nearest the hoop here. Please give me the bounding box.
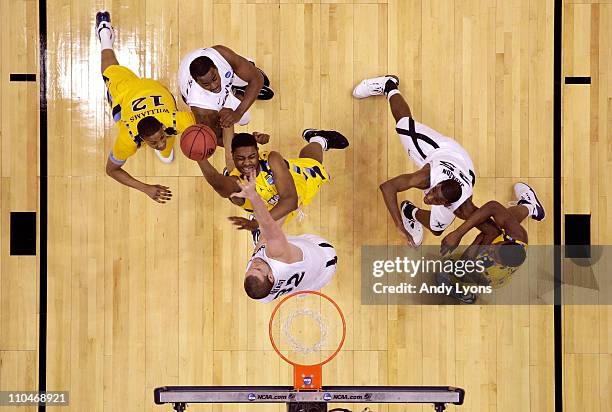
[247,235,338,303]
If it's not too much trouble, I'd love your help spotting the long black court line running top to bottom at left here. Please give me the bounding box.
[38,0,48,412]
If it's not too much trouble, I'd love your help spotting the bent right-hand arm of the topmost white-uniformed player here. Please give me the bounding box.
[213,45,263,126]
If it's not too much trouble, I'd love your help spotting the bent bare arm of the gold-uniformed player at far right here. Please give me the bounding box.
[441,200,527,254]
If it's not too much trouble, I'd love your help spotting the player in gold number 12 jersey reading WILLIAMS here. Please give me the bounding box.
[96,11,195,203]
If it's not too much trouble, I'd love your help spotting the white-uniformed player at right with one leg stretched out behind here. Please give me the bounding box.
[353,76,494,246]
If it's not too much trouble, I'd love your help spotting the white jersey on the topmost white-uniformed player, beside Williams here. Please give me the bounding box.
[179,47,234,111]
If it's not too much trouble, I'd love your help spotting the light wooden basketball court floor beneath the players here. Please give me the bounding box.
[0,0,612,412]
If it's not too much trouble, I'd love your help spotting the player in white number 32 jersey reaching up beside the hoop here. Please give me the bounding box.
[232,172,338,303]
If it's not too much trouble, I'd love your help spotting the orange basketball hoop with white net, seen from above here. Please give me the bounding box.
[269,290,346,390]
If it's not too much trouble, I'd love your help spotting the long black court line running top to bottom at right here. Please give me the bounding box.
[553,0,563,412]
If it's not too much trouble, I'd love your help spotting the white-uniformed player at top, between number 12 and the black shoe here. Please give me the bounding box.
[178,45,274,139]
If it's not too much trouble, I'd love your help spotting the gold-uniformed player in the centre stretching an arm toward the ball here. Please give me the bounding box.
[198,129,349,237]
